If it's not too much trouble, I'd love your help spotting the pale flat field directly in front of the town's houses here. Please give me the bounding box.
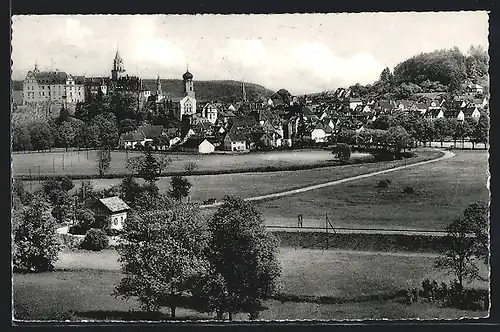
[12,150,356,176]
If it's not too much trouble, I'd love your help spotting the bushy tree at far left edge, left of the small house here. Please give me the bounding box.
[13,196,60,272]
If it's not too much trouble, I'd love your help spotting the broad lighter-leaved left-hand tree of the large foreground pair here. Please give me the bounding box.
[114,205,208,318]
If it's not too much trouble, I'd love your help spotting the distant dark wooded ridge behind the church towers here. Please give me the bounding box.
[12,79,274,102]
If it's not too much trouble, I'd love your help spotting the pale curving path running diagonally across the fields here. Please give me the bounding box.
[200,151,455,208]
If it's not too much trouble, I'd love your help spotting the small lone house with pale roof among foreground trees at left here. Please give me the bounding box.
[92,196,130,230]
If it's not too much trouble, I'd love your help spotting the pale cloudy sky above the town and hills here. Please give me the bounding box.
[12,12,488,95]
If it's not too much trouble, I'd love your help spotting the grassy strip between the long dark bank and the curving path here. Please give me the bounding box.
[38,151,442,202]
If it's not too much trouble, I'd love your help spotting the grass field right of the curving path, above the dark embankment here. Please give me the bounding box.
[257,151,489,230]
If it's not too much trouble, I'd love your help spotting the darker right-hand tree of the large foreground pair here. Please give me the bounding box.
[198,196,281,320]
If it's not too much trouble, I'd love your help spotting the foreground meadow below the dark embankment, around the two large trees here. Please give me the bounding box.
[14,248,487,319]
